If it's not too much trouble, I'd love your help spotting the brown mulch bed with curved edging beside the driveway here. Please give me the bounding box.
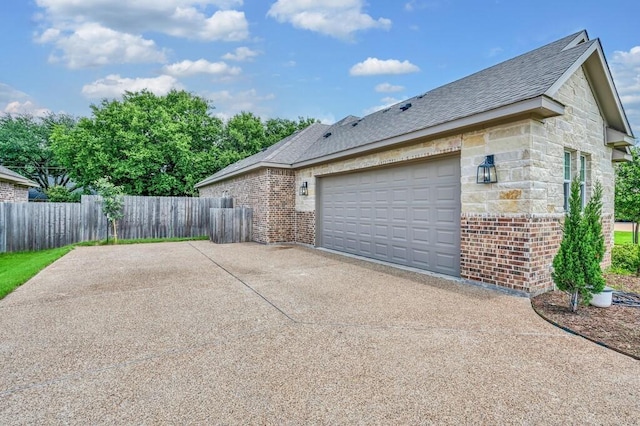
[531,274,640,359]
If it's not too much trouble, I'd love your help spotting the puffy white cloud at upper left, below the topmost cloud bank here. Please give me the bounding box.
[38,23,166,68]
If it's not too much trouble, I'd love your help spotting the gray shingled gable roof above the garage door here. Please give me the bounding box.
[196,31,633,187]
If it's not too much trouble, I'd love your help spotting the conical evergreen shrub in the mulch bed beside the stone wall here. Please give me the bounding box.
[551,179,605,312]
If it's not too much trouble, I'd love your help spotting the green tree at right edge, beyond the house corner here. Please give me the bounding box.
[615,147,640,244]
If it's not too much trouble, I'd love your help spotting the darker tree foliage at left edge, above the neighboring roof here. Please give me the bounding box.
[0,114,75,193]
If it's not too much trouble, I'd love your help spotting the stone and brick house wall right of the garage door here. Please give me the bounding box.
[461,69,614,294]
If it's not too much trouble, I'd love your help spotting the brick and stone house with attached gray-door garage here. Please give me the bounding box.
[196,31,634,294]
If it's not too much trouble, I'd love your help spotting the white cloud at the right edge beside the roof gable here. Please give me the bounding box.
[611,46,640,136]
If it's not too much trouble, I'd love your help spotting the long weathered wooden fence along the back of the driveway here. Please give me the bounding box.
[0,195,233,253]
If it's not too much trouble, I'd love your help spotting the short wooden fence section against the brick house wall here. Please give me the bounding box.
[209,207,253,244]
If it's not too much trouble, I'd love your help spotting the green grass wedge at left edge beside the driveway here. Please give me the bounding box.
[0,246,73,299]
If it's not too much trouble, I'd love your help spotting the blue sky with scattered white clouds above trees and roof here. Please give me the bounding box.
[0,0,640,136]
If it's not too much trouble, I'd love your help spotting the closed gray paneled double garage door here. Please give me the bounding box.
[317,157,460,276]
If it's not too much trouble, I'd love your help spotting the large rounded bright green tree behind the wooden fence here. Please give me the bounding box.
[52,90,223,195]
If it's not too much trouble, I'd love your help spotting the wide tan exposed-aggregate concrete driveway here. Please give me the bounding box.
[0,241,640,425]
